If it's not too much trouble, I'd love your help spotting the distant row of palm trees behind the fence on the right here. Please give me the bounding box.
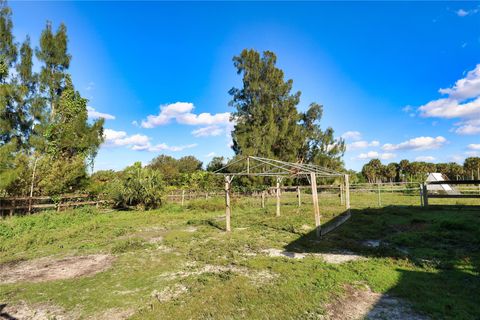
[357,157,480,183]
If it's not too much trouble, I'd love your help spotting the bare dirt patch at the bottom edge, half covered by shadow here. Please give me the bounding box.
[323,285,429,320]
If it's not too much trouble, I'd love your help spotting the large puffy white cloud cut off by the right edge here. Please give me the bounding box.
[418,64,480,134]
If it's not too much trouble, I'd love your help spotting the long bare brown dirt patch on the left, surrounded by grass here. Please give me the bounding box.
[0,254,115,283]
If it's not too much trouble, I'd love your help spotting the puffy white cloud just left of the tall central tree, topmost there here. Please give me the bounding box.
[141,102,230,128]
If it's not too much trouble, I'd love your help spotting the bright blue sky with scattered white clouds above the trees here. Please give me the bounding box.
[10,2,480,170]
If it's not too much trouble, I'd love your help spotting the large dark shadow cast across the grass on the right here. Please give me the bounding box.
[285,207,480,319]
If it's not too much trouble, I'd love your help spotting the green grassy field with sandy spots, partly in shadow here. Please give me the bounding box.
[0,193,480,319]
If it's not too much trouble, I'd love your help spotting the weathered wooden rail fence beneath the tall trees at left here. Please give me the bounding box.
[0,194,107,217]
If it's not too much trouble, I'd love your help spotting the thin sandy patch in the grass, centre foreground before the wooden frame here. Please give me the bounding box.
[160,264,278,284]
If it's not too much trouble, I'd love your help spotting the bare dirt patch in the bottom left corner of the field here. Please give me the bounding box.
[0,302,71,320]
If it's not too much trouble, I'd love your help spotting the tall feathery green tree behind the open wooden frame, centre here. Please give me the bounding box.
[229,49,345,169]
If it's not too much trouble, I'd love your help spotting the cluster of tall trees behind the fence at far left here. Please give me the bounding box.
[0,1,104,195]
